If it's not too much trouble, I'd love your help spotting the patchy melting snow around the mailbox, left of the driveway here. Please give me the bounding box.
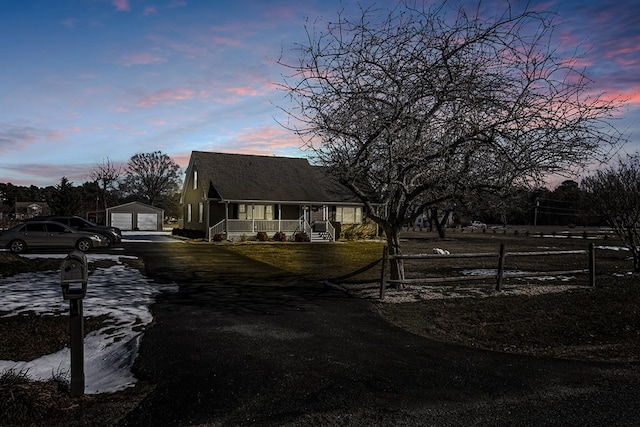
[0,254,178,394]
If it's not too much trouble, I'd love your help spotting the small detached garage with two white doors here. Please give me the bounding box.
[107,202,164,231]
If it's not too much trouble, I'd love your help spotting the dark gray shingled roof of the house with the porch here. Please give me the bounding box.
[191,151,358,203]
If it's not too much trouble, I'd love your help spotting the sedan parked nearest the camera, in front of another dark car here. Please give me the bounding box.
[0,221,108,253]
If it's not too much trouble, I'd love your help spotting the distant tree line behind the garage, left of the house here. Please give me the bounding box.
[0,151,181,222]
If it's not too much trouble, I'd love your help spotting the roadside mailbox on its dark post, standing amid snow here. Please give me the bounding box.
[60,251,88,396]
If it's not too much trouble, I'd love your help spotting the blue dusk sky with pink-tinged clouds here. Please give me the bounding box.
[0,0,640,186]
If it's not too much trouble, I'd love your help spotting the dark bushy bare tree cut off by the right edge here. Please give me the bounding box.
[582,153,640,273]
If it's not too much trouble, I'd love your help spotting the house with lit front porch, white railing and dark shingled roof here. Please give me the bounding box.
[181,151,364,241]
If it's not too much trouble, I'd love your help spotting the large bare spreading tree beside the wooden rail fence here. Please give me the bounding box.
[279,1,619,278]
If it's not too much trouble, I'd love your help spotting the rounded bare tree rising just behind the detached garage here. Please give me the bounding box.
[123,151,180,206]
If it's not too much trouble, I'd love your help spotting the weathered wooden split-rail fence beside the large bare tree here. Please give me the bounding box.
[380,243,596,299]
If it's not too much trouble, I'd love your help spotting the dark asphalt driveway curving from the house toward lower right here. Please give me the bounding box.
[117,242,640,426]
